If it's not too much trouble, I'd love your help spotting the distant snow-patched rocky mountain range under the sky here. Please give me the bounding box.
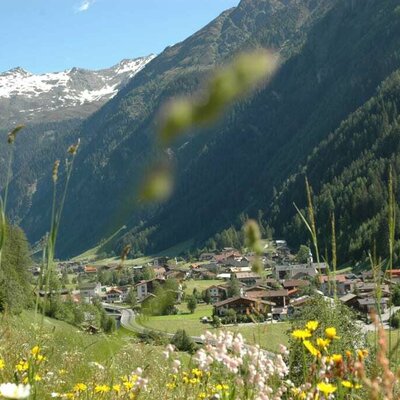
[0,54,155,127]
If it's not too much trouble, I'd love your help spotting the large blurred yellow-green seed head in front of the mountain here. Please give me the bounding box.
[140,50,278,201]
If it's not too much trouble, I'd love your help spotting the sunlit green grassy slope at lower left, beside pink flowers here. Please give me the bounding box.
[0,312,173,399]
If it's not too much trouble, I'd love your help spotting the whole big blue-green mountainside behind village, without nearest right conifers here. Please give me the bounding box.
[7,0,400,257]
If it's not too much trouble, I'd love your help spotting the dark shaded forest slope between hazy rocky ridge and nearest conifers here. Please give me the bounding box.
[134,1,400,256]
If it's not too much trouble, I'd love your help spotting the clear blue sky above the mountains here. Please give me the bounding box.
[0,0,239,73]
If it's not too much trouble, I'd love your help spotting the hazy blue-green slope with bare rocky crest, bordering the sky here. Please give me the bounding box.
[15,0,333,255]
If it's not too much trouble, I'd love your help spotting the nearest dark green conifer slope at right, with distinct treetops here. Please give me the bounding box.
[273,70,400,262]
